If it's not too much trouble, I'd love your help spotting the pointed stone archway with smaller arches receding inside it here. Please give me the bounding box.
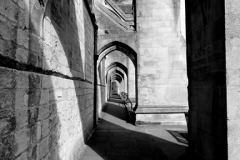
[95,41,138,122]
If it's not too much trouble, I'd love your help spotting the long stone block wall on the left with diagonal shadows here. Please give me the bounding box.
[0,0,94,160]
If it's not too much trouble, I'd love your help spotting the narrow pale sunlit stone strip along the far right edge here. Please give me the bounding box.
[225,0,240,160]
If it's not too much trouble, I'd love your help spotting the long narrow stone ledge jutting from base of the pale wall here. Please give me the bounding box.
[135,105,189,114]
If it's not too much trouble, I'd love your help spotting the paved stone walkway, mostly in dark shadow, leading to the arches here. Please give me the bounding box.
[83,100,187,160]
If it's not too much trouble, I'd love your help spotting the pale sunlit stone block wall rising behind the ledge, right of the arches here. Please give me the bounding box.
[136,0,188,123]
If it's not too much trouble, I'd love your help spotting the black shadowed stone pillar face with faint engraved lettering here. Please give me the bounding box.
[186,0,227,160]
